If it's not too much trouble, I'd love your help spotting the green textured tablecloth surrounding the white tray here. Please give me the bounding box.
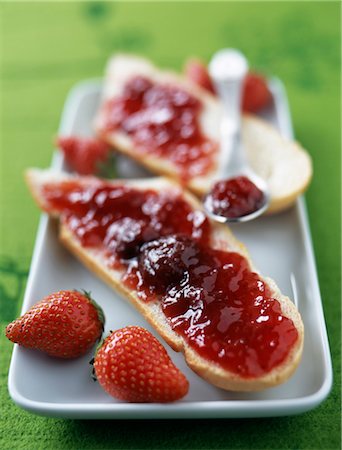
[0,1,341,449]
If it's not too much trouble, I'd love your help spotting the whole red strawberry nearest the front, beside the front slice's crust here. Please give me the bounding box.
[94,326,189,403]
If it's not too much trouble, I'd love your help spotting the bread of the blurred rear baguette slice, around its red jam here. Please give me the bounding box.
[95,55,312,213]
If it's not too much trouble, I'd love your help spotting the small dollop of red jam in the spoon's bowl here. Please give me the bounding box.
[206,176,265,219]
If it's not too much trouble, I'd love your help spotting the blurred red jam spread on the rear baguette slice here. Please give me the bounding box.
[101,76,217,179]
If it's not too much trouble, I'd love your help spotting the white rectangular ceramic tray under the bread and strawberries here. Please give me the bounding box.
[9,80,332,419]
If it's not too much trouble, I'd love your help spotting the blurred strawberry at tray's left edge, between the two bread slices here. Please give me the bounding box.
[57,136,113,177]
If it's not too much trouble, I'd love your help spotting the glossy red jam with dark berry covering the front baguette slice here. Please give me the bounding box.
[43,182,298,378]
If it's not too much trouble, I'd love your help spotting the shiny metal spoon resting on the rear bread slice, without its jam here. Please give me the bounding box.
[204,49,270,223]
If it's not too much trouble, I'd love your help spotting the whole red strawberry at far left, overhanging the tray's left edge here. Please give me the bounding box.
[6,291,104,358]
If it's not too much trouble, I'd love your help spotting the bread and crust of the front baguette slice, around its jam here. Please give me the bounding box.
[26,169,304,391]
